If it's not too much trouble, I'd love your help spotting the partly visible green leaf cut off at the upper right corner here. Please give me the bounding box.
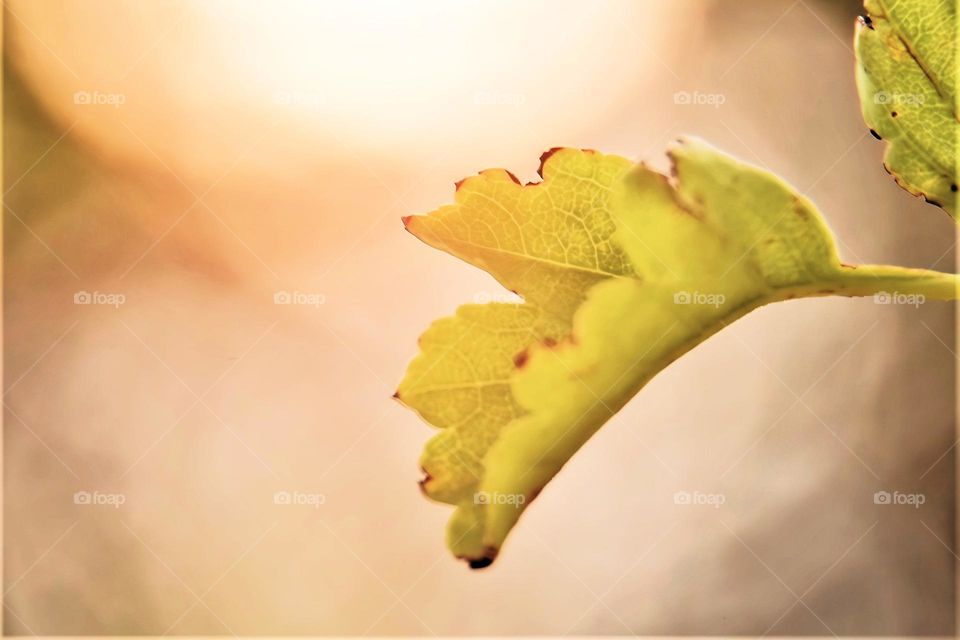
[856,0,960,218]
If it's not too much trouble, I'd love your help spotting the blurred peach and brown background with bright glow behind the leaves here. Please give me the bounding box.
[3,0,955,635]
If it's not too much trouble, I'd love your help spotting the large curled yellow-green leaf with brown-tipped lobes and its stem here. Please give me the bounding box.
[396,141,956,568]
